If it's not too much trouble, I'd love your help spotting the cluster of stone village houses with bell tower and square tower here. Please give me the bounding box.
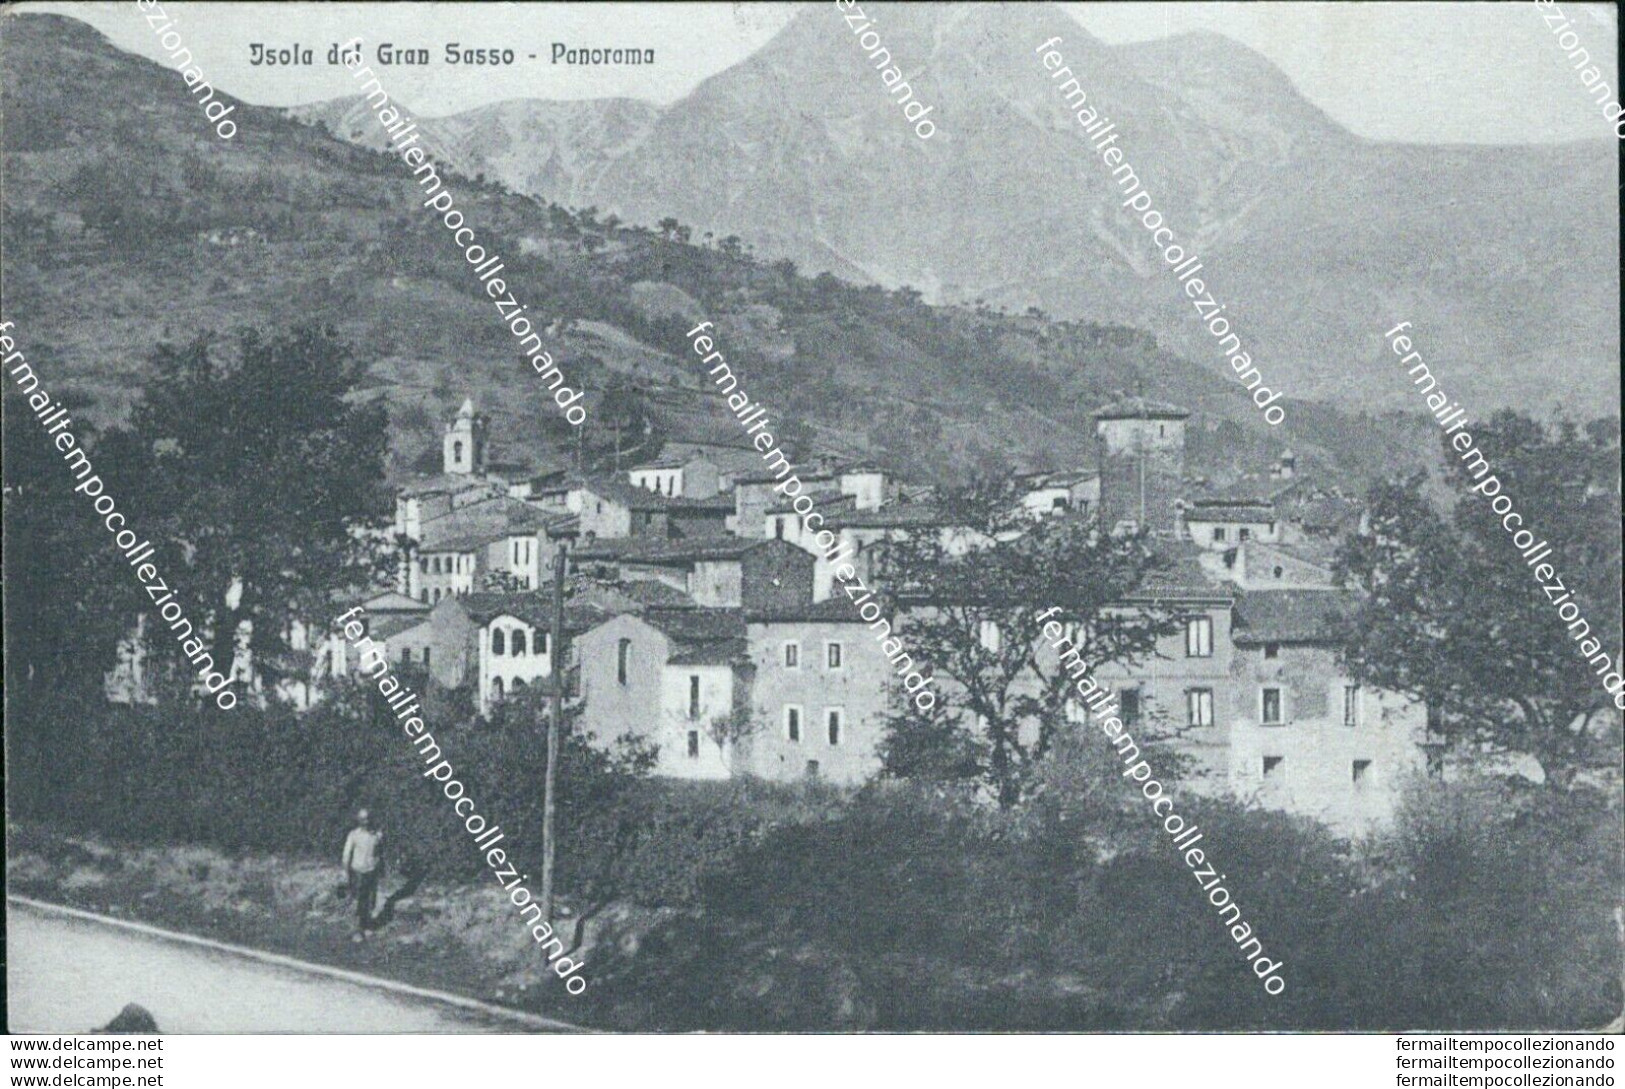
[109,386,1445,832]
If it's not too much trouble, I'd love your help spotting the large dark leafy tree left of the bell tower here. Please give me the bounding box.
[104,328,390,695]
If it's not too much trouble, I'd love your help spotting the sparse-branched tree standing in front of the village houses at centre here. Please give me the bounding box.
[878,483,1177,808]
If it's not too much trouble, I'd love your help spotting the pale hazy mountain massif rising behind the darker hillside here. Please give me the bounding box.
[279,3,1619,411]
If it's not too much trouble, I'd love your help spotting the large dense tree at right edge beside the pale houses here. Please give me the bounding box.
[1337,411,1620,790]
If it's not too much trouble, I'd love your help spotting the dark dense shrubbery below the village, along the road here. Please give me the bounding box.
[7,689,1622,1030]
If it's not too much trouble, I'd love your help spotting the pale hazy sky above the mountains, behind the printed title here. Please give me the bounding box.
[21,0,1619,143]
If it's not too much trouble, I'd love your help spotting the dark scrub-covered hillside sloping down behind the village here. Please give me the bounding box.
[0,15,1423,490]
